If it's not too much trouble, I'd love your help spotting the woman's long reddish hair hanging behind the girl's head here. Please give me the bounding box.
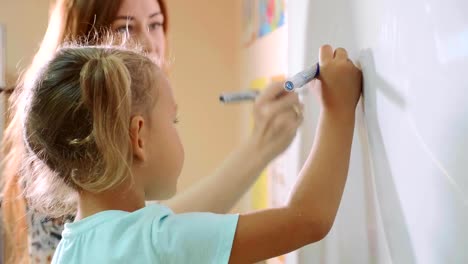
[0,0,169,263]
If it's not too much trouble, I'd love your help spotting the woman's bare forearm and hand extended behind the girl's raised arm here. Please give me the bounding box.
[164,83,302,213]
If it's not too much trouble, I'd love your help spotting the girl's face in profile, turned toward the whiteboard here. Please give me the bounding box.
[138,70,184,200]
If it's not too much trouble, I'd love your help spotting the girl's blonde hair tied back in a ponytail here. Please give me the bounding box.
[21,46,159,217]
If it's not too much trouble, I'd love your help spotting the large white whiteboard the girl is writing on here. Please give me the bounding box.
[288,0,468,264]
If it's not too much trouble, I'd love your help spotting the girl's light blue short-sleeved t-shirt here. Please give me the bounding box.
[52,204,239,264]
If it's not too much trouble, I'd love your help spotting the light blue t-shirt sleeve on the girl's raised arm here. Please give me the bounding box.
[152,213,239,264]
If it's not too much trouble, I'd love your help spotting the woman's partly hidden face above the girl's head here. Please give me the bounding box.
[112,0,166,59]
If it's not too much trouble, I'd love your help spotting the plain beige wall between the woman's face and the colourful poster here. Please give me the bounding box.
[166,0,244,210]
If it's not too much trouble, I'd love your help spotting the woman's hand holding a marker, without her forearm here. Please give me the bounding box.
[250,82,304,163]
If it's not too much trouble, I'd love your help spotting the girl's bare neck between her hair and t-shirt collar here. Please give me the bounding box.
[75,184,145,221]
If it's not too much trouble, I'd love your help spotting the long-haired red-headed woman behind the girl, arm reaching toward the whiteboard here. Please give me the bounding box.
[2,0,301,263]
